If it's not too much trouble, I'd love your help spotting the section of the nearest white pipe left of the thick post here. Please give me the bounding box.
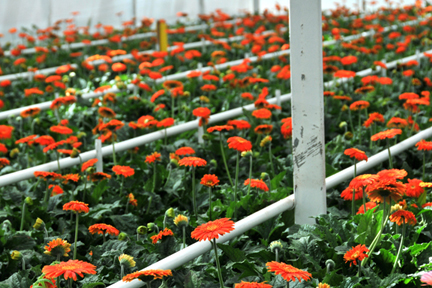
[108,195,294,288]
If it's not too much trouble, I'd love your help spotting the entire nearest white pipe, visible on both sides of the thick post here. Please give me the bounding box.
[108,128,432,288]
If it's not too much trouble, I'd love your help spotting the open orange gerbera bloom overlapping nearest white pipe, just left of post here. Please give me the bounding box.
[191,218,234,241]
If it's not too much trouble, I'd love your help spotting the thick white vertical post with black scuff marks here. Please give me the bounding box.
[289,0,327,224]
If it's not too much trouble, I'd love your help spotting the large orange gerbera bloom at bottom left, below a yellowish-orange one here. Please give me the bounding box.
[42,260,96,281]
